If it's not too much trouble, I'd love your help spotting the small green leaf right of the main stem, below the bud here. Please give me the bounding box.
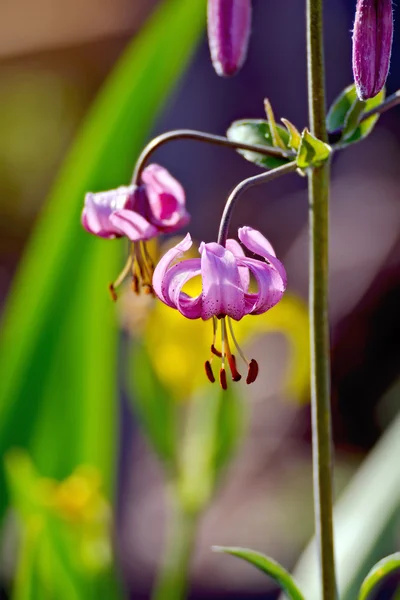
[326,85,385,147]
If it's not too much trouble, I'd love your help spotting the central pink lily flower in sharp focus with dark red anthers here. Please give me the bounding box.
[153,227,287,389]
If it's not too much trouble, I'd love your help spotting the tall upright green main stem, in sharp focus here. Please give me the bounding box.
[307,0,337,600]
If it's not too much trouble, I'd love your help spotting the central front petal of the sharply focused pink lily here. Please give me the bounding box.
[199,242,245,321]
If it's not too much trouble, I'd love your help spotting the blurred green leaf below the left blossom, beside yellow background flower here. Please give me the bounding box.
[128,343,178,466]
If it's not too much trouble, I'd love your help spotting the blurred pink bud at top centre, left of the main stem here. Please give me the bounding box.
[208,0,251,77]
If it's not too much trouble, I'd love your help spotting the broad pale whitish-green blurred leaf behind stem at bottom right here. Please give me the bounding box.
[286,398,400,600]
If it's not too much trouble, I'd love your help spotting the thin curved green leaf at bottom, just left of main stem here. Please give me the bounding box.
[212,546,304,600]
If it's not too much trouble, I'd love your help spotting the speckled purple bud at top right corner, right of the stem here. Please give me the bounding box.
[353,0,393,100]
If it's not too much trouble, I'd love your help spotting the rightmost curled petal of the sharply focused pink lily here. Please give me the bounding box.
[240,258,286,315]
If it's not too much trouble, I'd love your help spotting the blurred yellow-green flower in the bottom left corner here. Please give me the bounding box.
[5,450,112,577]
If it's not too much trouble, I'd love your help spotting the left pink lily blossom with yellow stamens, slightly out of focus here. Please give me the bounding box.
[82,164,190,300]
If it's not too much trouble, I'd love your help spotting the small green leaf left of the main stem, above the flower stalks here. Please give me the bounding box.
[226,119,290,169]
